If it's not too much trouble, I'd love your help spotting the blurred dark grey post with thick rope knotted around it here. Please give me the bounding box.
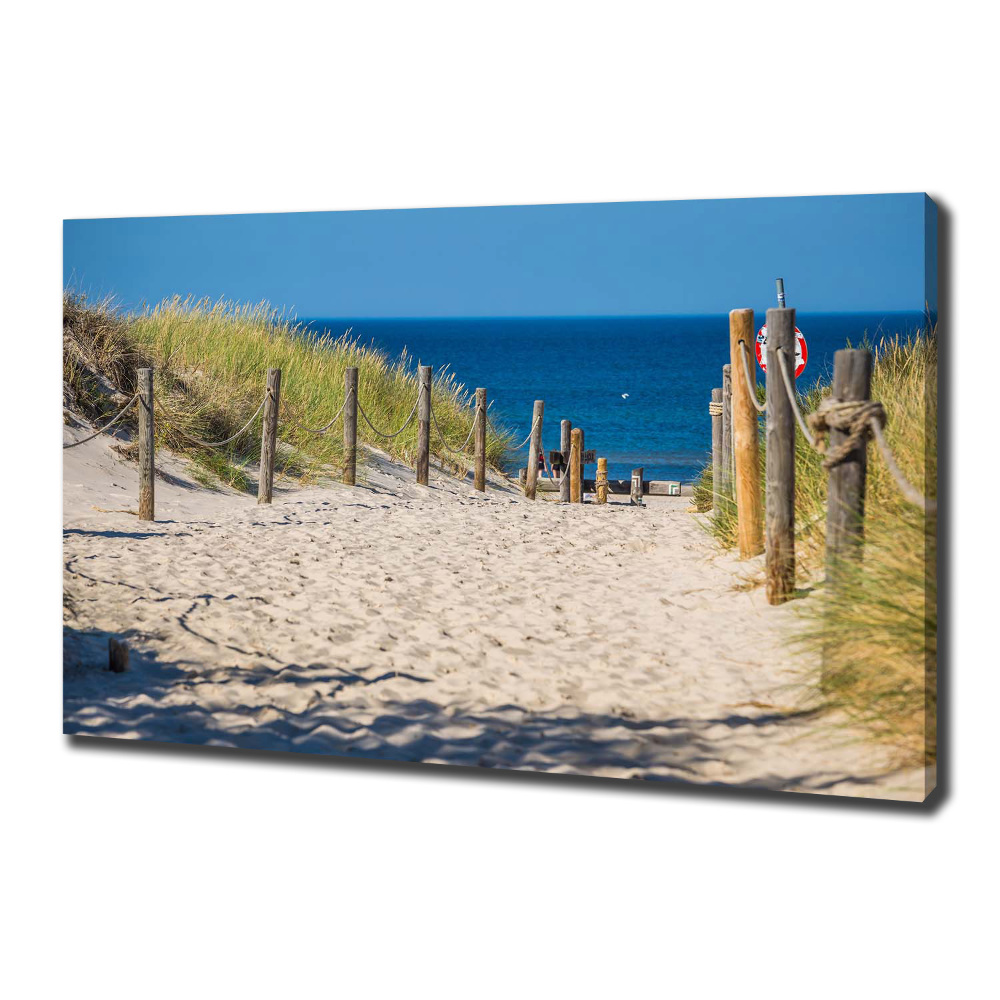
[824,350,872,581]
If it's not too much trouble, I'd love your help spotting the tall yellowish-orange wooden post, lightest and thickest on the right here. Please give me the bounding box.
[729,309,764,559]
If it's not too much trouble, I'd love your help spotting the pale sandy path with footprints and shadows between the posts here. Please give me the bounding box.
[64,430,930,799]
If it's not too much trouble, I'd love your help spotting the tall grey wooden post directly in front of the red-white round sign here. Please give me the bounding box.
[764,309,795,604]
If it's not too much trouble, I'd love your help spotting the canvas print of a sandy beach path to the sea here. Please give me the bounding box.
[62,194,937,801]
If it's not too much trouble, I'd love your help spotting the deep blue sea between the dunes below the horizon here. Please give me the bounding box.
[303,312,925,481]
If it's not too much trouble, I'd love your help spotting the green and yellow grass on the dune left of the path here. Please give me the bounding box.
[63,291,510,490]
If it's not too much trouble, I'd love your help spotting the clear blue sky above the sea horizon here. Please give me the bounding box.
[63,194,937,318]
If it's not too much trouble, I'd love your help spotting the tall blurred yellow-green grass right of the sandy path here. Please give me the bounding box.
[694,332,937,764]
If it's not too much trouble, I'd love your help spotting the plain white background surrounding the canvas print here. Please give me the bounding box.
[0,0,1000,998]
